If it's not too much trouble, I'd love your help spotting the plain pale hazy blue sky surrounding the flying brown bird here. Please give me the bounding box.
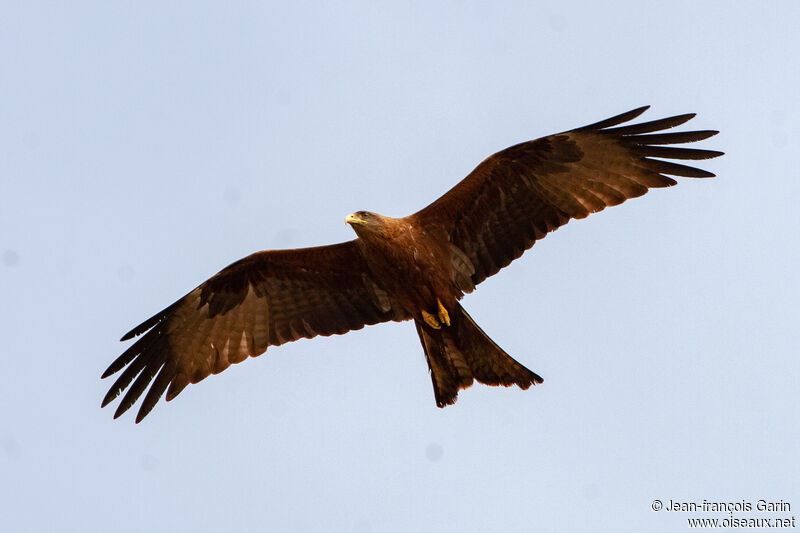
[0,1,800,532]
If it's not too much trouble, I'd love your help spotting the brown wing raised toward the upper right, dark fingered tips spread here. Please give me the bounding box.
[409,106,722,285]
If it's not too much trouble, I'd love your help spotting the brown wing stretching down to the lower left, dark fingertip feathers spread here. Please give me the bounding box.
[103,241,409,423]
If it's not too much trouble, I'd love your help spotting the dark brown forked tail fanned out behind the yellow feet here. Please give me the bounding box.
[416,305,542,407]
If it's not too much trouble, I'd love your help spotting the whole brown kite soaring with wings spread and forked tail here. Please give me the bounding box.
[102,106,722,423]
